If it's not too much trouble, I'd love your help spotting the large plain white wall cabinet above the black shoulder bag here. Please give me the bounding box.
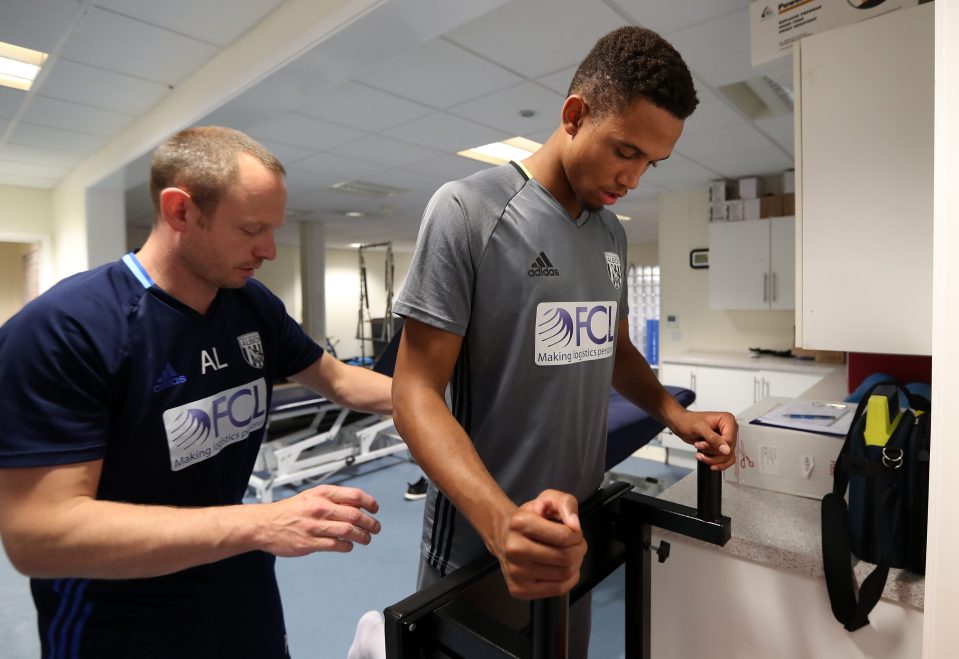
[796,2,935,355]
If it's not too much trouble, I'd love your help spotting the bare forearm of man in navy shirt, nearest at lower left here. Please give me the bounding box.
[3,497,271,579]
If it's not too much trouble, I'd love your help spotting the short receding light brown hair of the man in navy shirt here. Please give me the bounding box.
[150,126,286,222]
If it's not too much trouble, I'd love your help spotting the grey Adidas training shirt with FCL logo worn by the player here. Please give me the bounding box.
[393,163,628,574]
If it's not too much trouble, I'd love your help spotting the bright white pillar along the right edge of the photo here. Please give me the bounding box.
[924,0,959,658]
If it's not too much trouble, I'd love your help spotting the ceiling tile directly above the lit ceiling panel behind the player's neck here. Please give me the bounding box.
[447,82,566,138]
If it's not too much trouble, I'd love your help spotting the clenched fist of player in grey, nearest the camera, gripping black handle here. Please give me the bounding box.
[494,490,586,600]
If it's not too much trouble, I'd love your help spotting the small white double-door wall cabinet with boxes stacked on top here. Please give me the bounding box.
[709,216,796,309]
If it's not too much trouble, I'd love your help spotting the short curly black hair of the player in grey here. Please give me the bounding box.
[569,25,699,119]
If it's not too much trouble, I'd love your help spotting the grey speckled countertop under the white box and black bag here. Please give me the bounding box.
[656,471,925,610]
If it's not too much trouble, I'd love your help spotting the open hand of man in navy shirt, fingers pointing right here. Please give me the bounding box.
[257,485,380,556]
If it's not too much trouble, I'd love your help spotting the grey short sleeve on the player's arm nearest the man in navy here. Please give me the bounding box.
[393,183,475,336]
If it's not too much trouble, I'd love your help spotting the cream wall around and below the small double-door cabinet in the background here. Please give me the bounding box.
[659,188,795,356]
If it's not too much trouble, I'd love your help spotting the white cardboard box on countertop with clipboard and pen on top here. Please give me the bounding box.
[723,397,845,499]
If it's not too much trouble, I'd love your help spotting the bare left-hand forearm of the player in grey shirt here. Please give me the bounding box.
[393,386,516,553]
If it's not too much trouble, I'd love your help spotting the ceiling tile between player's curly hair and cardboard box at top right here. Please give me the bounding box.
[669,8,756,89]
